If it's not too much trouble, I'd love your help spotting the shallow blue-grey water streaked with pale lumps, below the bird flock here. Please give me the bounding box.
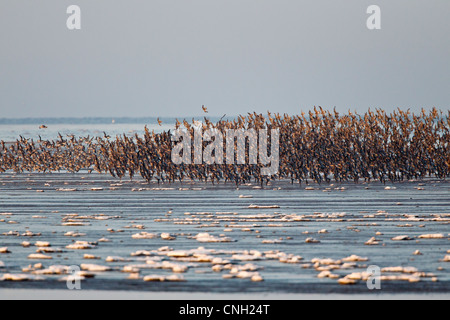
[0,173,450,293]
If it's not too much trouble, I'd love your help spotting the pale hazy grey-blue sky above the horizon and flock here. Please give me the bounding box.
[0,0,450,118]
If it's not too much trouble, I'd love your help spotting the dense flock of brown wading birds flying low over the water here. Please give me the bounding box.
[0,107,450,185]
